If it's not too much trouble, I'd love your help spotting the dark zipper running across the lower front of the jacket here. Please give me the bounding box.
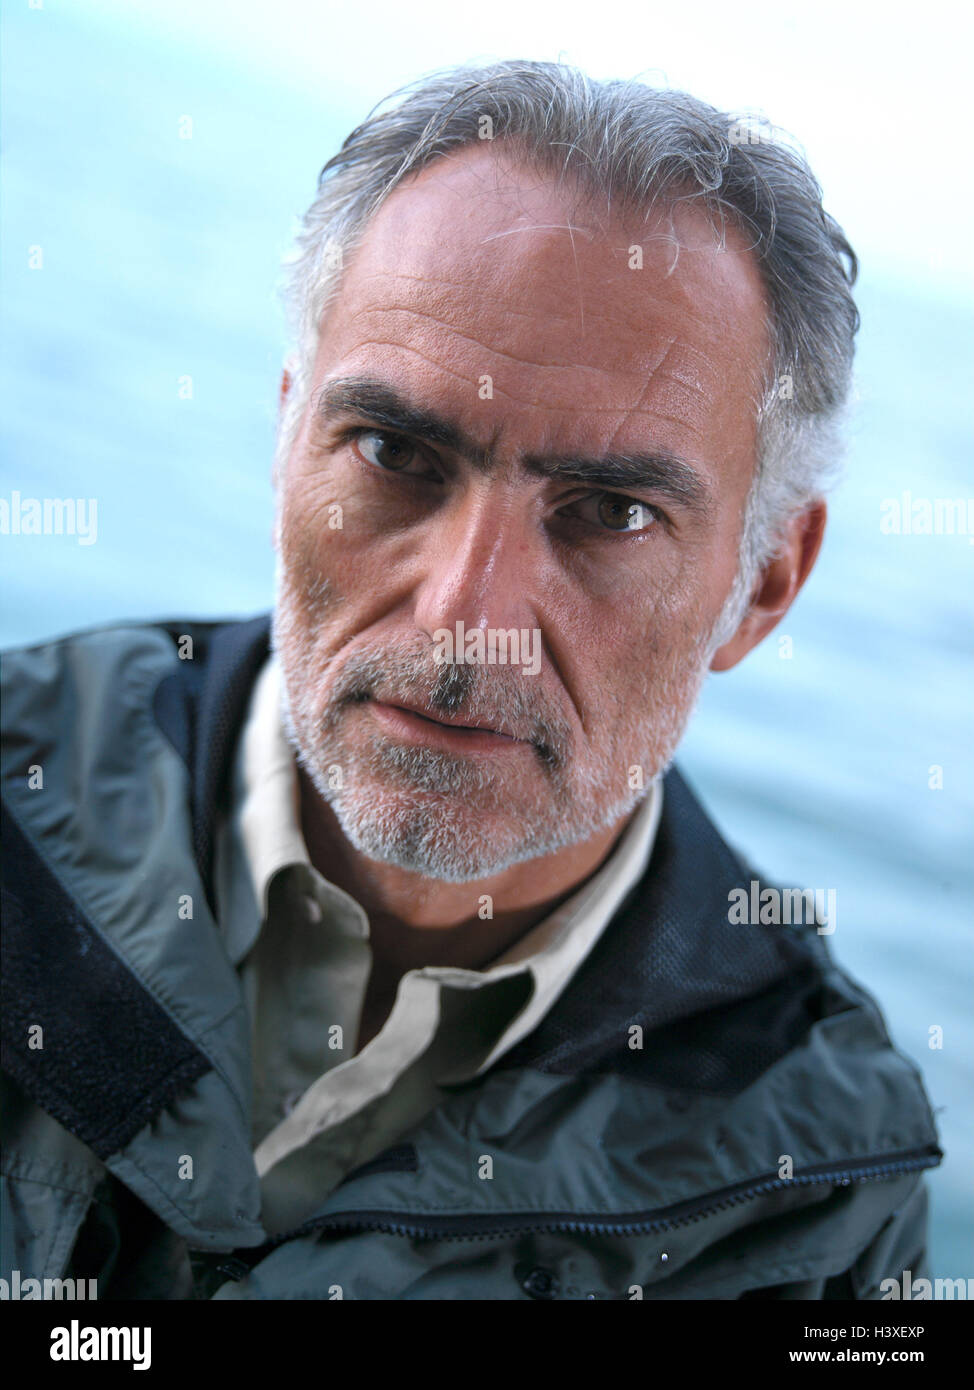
[220,1144,943,1279]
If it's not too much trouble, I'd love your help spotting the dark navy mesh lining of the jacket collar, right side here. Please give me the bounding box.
[497,769,828,1095]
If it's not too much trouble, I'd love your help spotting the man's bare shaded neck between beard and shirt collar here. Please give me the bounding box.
[299,767,635,983]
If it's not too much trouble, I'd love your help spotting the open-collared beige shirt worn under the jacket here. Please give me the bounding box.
[217,656,663,1234]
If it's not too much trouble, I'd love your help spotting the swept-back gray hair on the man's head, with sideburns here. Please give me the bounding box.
[275,60,859,646]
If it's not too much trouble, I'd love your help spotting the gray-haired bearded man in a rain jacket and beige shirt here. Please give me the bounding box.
[4,63,941,1300]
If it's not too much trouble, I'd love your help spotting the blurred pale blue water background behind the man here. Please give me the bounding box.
[0,0,974,1279]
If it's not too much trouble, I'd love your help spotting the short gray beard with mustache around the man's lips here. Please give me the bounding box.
[272,569,707,883]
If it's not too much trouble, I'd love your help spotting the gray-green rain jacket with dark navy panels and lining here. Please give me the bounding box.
[0,616,942,1300]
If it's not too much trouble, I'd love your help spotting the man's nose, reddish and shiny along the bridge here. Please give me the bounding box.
[414,480,540,639]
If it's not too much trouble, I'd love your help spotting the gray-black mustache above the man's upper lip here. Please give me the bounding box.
[325,645,572,767]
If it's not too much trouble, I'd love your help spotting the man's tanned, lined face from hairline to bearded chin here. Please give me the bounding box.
[274,142,768,883]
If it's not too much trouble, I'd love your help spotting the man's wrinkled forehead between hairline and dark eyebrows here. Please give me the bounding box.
[317,142,770,469]
